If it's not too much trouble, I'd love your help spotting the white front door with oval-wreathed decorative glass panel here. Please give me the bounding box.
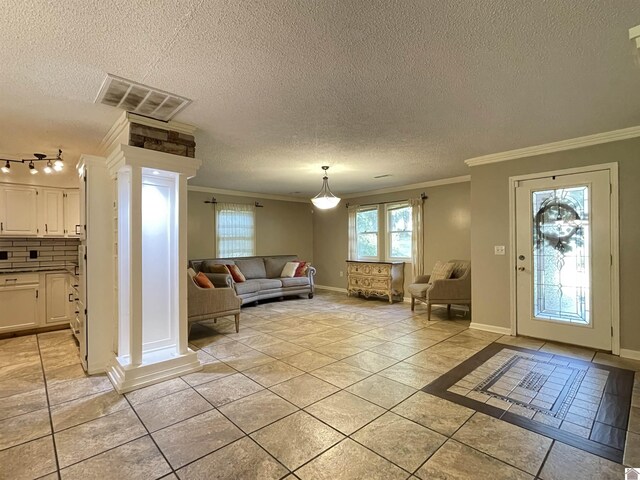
[515,170,612,350]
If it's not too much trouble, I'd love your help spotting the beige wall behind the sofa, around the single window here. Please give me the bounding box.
[187,191,313,261]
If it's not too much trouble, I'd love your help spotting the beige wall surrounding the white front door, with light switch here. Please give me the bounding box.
[471,139,640,350]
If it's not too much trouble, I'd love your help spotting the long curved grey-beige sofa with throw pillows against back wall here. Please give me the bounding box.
[189,255,316,304]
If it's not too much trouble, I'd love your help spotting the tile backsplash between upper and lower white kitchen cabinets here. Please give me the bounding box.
[0,237,80,273]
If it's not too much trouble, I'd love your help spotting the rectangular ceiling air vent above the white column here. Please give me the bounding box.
[95,74,191,122]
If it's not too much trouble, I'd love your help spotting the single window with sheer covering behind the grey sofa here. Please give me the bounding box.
[216,203,256,258]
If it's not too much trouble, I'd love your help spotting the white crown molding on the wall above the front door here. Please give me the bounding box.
[464,126,640,167]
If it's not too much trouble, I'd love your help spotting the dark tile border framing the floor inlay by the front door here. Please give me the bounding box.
[422,343,635,463]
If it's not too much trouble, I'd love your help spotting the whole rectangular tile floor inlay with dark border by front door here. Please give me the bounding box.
[422,343,634,462]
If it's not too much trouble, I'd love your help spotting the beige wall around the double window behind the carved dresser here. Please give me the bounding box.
[313,182,471,296]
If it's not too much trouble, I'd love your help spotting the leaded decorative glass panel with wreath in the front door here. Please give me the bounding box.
[531,185,591,325]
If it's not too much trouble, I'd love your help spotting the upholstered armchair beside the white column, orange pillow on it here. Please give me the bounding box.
[187,275,242,333]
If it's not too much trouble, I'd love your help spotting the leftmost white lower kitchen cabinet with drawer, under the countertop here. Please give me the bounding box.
[0,274,40,333]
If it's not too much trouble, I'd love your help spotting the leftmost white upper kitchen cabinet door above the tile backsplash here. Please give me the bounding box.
[0,184,38,237]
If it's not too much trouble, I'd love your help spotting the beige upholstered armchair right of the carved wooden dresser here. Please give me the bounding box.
[409,260,471,320]
